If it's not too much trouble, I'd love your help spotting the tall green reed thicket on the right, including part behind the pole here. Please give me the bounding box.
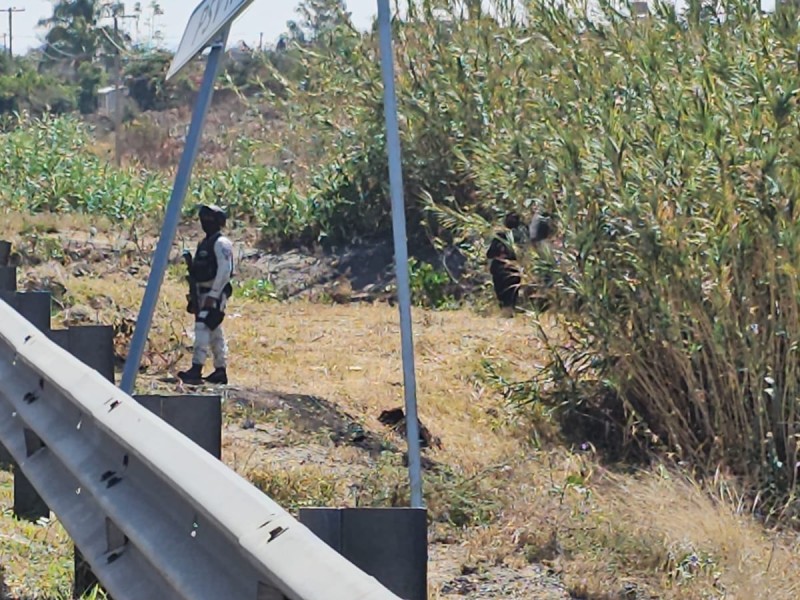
[276,0,800,509]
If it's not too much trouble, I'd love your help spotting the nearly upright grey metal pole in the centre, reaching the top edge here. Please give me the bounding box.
[378,0,423,508]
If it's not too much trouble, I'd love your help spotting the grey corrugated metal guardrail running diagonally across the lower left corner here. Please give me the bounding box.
[0,301,400,600]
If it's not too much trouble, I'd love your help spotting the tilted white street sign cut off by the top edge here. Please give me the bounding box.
[167,0,253,81]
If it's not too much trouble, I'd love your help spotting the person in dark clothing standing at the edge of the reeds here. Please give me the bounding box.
[486,212,527,310]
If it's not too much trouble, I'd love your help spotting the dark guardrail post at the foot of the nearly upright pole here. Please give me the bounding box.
[298,508,428,600]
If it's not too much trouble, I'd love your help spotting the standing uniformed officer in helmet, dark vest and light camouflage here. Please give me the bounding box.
[178,205,234,384]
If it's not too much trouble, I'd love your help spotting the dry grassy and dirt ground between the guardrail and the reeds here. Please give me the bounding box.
[0,220,800,600]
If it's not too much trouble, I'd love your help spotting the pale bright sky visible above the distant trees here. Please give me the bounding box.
[5,0,377,54]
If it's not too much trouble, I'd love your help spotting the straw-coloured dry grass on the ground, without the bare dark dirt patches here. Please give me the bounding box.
[0,217,800,599]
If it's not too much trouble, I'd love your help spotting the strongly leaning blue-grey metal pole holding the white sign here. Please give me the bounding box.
[120,25,230,394]
